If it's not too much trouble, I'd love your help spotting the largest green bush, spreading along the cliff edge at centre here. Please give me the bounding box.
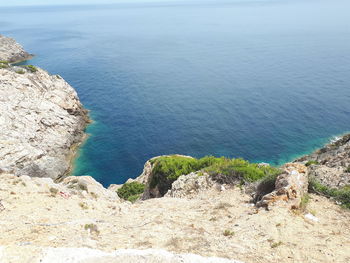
[150,156,281,196]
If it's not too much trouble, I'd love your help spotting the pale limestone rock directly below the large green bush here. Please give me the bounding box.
[165,172,214,198]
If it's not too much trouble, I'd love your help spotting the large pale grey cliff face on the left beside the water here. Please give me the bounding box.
[0,67,88,179]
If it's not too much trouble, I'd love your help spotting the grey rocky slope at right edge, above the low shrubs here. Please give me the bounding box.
[295,134,350,188]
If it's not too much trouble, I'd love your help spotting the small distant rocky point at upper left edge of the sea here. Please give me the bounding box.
[0,35,32,63]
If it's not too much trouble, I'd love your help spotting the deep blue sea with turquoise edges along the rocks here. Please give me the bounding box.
[0,0,350,188]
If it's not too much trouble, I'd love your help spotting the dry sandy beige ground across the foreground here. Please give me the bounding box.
[0,176,350,263]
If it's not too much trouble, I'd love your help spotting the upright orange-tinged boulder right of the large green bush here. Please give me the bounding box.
[257,163,308,209]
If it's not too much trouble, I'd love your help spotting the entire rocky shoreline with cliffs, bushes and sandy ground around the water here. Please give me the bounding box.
[0,36,350,263]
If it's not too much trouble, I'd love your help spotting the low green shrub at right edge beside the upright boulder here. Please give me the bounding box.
[309,178,350,209]
